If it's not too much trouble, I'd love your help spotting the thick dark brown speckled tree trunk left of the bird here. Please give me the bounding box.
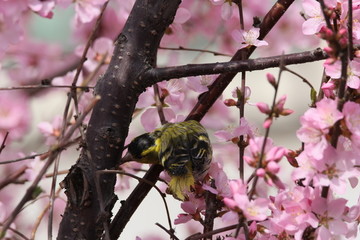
[58,0,180,240]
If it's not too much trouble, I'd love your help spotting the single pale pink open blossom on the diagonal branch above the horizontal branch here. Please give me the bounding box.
[231,27,268,49]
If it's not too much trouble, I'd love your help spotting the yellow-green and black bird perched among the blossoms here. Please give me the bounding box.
[121,120,212,201]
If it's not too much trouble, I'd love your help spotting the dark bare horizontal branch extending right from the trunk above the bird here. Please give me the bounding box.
[146,48,327,82]
